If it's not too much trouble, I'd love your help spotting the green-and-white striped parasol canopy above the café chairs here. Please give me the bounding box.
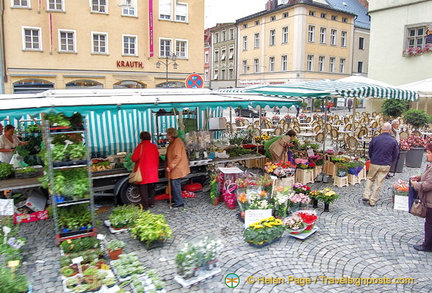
[241,79,418,101]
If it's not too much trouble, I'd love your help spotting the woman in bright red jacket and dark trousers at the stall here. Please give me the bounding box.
[131,131,159,210]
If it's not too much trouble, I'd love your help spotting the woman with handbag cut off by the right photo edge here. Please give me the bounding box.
[411,143,432,252]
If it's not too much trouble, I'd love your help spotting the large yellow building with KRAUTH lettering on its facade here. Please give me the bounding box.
[0,0,204,93]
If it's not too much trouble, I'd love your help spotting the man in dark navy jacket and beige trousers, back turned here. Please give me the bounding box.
[363,122,399,207]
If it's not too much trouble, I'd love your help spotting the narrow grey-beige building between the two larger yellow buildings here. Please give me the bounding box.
[210,23,237,89]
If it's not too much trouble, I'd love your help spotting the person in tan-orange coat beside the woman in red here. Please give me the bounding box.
[165,128,190,208]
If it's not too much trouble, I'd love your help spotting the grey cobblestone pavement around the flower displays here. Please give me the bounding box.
[21,153,432,293]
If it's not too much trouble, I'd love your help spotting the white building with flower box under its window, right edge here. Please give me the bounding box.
[367,0,432,110]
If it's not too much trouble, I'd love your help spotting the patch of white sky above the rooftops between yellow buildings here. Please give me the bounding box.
[204,0,267,28]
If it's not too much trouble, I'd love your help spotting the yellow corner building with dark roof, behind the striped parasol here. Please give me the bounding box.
[237,1,355,87]
